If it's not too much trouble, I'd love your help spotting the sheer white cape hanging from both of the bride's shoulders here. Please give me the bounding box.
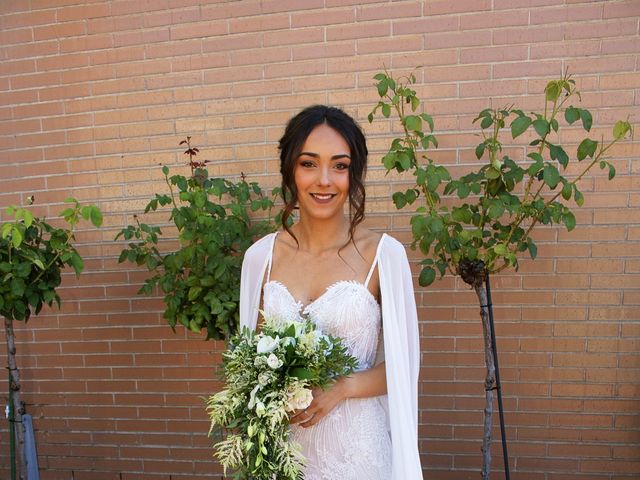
[240,234,422,480]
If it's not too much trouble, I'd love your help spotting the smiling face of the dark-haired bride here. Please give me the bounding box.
[294,124,351,219]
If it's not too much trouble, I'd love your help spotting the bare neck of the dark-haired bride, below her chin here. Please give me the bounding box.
[292,216,349,255]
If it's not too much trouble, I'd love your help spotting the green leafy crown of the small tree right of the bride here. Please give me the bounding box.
[369,72,633,286]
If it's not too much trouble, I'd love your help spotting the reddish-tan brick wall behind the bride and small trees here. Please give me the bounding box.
[0,0,640,480]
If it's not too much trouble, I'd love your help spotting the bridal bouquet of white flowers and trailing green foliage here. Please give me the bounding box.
[207,317,357,480]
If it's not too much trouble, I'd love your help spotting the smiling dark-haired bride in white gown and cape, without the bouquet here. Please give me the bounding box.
[240,105,422,480]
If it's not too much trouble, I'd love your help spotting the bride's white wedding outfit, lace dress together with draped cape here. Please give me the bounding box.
[240,233,422,480]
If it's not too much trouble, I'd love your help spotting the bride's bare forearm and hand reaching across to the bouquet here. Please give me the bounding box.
[291,362,387,427]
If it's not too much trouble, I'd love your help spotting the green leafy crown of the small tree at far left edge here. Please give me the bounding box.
[0,198,102,322]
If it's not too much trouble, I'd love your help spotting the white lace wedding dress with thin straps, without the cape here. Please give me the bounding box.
[263,234,391,480]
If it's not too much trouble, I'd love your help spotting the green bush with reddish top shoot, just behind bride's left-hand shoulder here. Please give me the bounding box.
[116,137,281,340]
